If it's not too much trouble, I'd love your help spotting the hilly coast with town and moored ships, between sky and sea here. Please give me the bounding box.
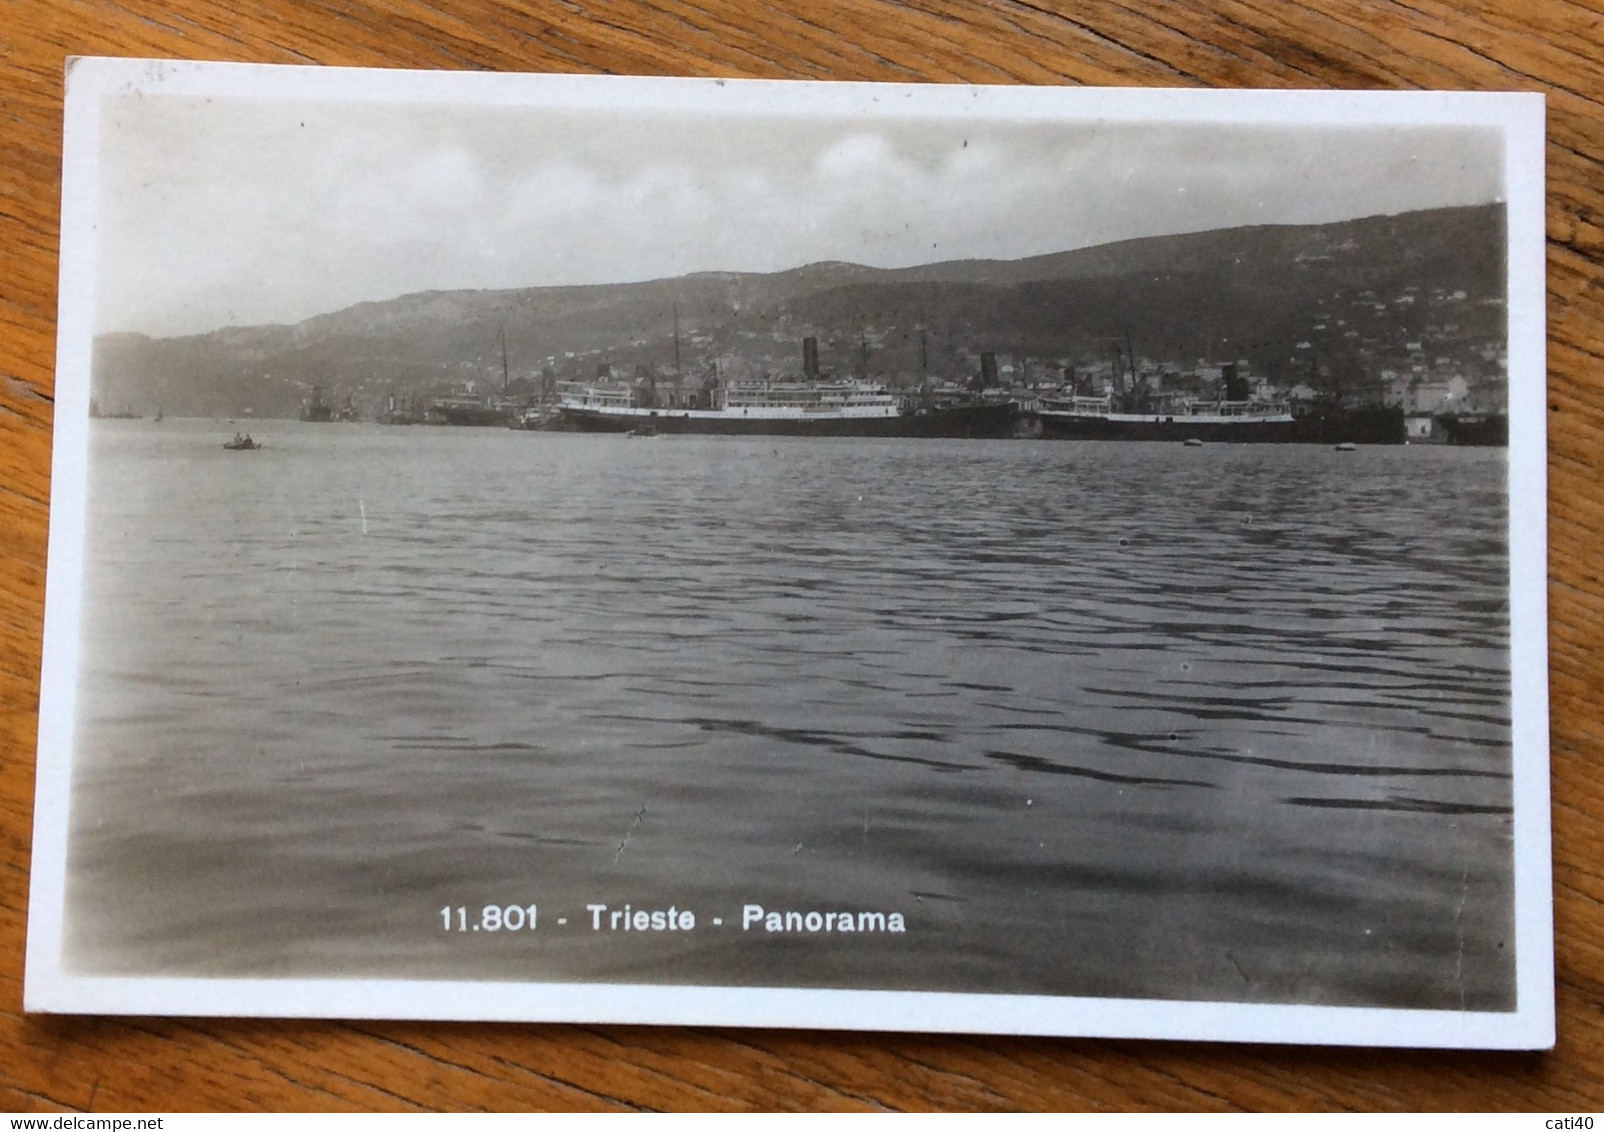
[95,205,1508,444]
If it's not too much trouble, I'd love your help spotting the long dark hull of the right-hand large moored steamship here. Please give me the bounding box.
[1036,409,1407,444]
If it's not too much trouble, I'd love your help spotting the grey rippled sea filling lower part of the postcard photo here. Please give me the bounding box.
[67,420,1514,1009]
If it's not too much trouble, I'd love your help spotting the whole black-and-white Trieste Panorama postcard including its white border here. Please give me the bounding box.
[26,59,1553,1047]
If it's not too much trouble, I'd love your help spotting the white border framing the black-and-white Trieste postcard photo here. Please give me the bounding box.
[24,59,1554,1049]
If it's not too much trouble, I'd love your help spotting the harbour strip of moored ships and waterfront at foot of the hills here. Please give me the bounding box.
[169,337,1508,447]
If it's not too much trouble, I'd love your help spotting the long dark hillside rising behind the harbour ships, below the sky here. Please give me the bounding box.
[95,205,1505,417]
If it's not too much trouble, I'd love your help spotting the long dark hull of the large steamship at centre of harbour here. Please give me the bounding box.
[561,404,1019,439]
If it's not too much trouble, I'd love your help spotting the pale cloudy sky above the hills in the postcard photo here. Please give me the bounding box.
[96,95,1503,337]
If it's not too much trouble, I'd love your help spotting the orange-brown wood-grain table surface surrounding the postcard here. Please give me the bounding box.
[0,0,1604,1111]
